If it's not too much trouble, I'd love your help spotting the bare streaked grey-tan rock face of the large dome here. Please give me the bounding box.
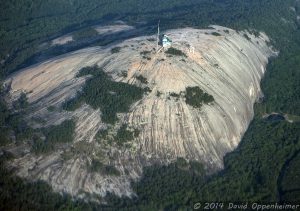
[2,26,275,200]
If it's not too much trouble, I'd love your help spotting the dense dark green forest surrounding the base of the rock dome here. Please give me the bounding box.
[0,0,300,210]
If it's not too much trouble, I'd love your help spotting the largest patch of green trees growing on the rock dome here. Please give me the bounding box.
[63,66,144,124]
